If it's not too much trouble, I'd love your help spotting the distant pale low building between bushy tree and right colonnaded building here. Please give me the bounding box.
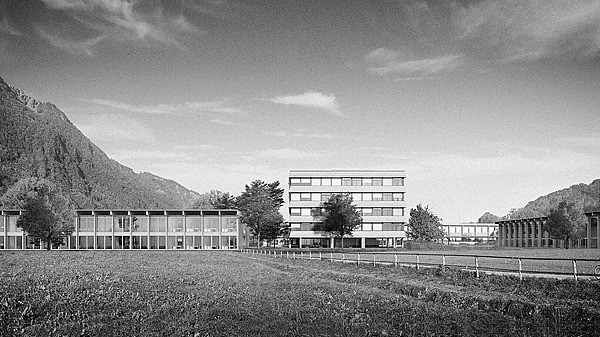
[442,223,498,244]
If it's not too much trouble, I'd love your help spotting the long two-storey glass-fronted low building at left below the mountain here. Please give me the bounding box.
[0,210,247,249]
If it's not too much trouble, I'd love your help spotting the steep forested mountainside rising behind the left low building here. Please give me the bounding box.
[0,77,199,209]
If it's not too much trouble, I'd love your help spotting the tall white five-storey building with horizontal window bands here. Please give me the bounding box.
[288,170,407,248]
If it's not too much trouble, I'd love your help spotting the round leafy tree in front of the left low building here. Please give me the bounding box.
[2,178,75,250]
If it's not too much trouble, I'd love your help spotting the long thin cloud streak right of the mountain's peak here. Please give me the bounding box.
[88,99,247,116]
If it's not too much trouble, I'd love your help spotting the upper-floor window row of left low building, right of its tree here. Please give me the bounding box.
[78,216,237,233]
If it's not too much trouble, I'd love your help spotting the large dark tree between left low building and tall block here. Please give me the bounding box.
[236,180,284,246]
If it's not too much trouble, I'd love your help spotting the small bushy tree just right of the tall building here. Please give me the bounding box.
[406,204,444,242]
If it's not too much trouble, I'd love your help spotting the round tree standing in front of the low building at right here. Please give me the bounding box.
[543,201,586,248]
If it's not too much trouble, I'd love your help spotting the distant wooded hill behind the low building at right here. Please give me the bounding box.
[478,179,600,222]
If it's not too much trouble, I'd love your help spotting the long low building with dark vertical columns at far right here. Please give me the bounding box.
[496,212,600,249]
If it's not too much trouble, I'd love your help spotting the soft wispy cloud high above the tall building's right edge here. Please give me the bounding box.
[367,48,463,79]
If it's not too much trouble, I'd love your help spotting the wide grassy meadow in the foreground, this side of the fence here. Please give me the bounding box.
[0,251,600,336]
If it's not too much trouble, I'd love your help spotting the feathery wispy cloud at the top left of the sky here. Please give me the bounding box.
[37,0,201,55]
